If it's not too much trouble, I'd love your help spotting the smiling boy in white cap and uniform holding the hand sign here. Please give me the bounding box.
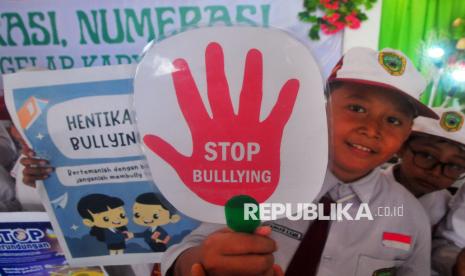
[162,48,437,276]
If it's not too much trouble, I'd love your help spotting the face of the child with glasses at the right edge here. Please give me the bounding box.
[398,135,465,197]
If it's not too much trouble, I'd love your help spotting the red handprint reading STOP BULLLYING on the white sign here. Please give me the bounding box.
[144,43,299,205]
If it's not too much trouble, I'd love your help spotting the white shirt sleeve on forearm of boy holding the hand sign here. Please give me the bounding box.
[161,223,226,275]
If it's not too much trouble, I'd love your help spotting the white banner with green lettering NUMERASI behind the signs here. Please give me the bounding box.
[0,0,342,88]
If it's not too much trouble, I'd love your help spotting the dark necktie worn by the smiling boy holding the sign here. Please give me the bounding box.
[285,196,334,276]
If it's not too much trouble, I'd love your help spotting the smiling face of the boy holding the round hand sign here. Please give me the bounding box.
[327,83,413,182]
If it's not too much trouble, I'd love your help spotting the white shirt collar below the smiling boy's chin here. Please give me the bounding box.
[327,168,380,203]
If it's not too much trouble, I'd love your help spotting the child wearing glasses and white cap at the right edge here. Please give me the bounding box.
[385,108,465,276]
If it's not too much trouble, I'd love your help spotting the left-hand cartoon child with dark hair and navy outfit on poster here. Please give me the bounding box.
[77,194,132,255]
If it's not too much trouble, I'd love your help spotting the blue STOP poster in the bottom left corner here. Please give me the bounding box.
[0,212,105,276]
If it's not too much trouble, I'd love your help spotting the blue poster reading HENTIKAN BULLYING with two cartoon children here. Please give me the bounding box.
[4,65,198,265]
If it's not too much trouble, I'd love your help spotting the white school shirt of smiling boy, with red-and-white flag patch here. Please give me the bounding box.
[161,169,431,276]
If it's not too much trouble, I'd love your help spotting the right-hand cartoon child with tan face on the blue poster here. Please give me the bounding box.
[133,193,181,252]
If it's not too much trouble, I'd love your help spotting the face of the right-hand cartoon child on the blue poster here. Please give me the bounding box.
[133,202,171,227]
